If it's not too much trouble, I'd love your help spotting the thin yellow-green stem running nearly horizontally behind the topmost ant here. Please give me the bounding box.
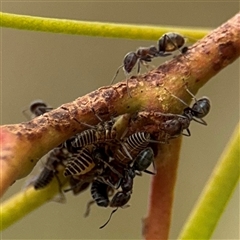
[0,12,210,42]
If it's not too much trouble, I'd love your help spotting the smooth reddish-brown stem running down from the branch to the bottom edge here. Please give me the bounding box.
[143,138,182,240]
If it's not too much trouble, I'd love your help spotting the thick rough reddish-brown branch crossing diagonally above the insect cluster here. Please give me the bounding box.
[0,11,240,201]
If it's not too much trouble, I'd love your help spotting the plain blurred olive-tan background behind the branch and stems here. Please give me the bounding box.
[1,0,239,239]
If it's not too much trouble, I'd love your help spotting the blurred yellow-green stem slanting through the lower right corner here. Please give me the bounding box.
[179,123,240,239]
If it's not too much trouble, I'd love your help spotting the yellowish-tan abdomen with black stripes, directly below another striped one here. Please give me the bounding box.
[63,148,95,177]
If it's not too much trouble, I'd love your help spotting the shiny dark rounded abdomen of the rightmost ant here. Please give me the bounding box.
[192,97,211,118]
